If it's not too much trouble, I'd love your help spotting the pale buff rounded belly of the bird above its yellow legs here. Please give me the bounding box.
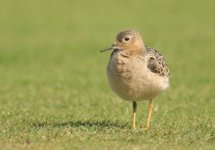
[107,59,168,101]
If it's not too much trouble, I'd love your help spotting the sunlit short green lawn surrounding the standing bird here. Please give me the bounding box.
[0,0,215,150]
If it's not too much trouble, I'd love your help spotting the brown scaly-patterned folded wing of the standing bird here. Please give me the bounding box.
[146,47,170,76]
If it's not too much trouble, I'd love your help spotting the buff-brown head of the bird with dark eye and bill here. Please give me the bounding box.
[101,30,145,52]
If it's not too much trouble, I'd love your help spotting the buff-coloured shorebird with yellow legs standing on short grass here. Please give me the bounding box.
[101,30,170,130]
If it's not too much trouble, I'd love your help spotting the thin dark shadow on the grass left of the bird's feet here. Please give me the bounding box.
[33,120,128,129]
